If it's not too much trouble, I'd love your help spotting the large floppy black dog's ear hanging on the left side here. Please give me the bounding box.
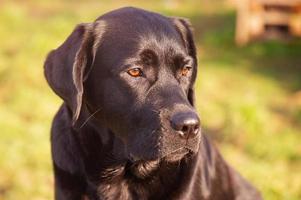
[44,22,103,124]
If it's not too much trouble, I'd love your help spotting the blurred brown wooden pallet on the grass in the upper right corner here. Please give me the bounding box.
[235,0,301,45]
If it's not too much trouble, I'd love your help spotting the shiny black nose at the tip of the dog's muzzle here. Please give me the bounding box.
[170,112,200,139]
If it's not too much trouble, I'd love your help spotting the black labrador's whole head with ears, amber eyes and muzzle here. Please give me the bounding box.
[45,8,200,165]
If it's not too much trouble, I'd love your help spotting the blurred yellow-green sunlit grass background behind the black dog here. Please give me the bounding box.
[0,0,301,200]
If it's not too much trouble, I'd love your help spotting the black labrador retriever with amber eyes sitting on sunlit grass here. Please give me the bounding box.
[45,8,261,200]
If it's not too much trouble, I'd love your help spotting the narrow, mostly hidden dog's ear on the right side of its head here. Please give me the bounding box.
[171,17,198,106]
